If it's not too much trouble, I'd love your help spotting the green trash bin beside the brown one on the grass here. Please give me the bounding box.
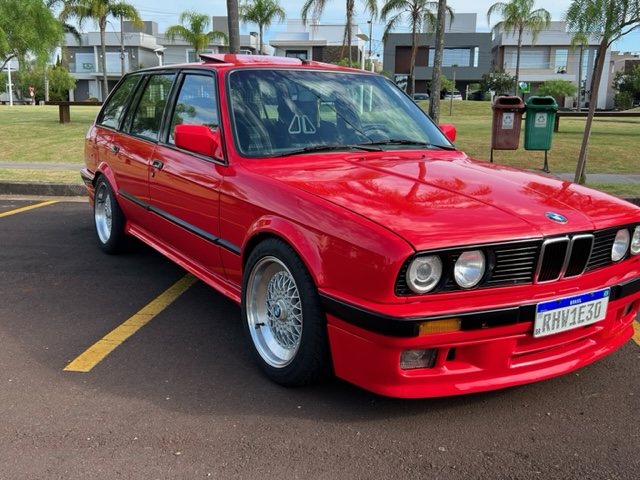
[524,97,558,151]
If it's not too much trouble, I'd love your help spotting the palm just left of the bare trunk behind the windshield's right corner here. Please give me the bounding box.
[380,0,453,94]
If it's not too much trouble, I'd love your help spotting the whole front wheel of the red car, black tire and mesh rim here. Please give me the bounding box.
[241,238,331,387]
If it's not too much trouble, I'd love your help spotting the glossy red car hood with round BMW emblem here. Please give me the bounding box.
[258,151,638,250]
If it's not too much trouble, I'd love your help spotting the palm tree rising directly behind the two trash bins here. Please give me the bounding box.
[487,0,551,95]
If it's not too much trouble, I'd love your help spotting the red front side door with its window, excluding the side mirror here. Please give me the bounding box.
[149,70,226,275]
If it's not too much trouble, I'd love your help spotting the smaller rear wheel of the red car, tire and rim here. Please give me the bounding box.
[93,177,131,254]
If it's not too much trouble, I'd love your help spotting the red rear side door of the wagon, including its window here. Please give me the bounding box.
[110,72,175,232]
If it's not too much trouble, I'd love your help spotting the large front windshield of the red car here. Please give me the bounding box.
[228,69,452,157]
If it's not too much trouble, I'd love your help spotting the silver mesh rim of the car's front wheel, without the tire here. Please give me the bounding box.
[245,256,303,369]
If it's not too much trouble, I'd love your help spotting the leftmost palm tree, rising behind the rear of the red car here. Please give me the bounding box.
[59,0,144,100]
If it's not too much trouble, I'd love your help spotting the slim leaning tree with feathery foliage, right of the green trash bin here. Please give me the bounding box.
[564,0,640,183]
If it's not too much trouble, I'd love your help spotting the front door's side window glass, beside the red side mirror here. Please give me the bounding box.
[169,74,218,143]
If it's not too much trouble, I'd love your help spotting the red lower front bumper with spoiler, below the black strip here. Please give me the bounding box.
[327,278,640,398]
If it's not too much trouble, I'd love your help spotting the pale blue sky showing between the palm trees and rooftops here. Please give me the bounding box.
[129,0,640,54]
